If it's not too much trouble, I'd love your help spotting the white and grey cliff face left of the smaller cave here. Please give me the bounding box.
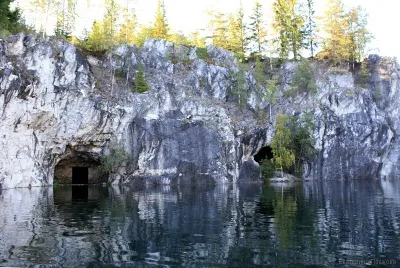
[0,34,267,188]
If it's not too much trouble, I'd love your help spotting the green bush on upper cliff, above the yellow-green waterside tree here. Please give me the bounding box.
[293,59,317,94]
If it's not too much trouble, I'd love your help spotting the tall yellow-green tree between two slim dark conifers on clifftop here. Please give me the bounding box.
[273,0,305,60]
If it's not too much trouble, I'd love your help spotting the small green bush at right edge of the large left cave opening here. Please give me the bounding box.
[101,139,130,173]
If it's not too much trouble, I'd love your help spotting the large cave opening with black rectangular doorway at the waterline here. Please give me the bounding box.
[54,152,109,185]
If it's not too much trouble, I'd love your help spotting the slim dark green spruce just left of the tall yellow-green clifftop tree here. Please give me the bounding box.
[248,1,267,55]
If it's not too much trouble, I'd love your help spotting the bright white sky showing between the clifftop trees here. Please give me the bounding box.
[5,0,397,59]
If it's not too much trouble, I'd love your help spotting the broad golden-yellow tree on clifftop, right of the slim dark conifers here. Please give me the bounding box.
[322,0,350,64]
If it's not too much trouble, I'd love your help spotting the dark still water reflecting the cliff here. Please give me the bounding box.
[0,181,400,267]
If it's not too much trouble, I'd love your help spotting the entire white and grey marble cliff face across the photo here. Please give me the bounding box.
[0,34,400,188]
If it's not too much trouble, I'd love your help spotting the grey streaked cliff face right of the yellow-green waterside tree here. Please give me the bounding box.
[282,56,400,179]
